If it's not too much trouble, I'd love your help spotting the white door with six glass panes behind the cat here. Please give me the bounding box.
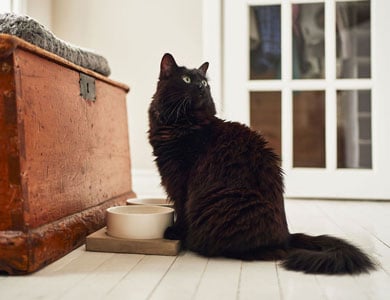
[224,0,390,199]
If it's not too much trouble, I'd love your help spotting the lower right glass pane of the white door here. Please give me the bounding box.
[337,90,372,169]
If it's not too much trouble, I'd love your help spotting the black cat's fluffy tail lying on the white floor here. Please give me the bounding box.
[282,233,375,274]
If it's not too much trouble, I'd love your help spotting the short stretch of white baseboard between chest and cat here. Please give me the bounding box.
[132,169,166,197]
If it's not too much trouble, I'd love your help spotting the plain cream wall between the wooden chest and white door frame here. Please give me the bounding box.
[46,0,202,178]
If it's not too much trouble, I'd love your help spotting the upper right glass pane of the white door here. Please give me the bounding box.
[336,1,371,78]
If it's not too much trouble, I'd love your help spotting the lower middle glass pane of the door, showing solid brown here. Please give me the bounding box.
[293,91,326,168]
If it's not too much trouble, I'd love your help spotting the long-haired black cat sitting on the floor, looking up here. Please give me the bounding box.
[149,54,374,274]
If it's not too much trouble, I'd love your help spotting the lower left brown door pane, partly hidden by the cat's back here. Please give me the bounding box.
[250,92,282,156]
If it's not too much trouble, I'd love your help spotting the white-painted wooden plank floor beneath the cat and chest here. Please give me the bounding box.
[0,200,390,300]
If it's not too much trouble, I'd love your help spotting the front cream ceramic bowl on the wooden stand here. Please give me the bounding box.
[107,205,173,239]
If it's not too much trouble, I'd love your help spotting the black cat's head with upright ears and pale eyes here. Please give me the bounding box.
[149,53,216,125]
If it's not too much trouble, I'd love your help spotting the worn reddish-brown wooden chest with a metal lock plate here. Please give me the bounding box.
[0,34,135,274]
